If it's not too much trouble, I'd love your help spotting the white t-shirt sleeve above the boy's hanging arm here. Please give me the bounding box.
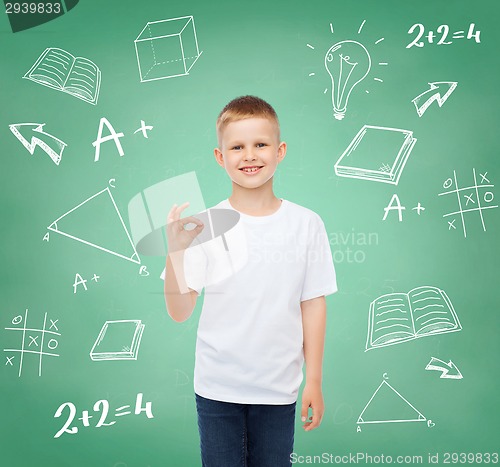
[300,214,338,302]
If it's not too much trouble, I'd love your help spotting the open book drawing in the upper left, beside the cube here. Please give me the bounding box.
[23,47,101,105]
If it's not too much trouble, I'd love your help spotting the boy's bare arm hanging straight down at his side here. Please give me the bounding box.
[300,296,326,431]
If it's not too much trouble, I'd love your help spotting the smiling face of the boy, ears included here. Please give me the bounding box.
[214,118,286,188]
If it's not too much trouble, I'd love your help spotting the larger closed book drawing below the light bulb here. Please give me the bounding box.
[335,125,417,185]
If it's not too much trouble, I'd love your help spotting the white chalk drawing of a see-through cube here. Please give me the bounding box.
[134,16,201,82]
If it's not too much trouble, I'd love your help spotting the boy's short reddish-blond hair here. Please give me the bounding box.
[216,96,280,143]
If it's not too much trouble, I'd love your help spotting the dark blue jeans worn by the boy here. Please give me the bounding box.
[196,394,295,467]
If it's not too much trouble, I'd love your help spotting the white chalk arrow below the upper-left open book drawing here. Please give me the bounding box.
[9,123,67,165]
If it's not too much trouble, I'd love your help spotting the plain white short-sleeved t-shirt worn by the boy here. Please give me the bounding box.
[162,199,337,405]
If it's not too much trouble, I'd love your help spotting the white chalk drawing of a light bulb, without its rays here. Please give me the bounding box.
[325,40,372,120]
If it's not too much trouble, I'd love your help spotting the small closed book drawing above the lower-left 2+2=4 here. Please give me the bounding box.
[90,319,144,361]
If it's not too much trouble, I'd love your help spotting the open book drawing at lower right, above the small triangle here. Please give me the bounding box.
[366,286,462,350]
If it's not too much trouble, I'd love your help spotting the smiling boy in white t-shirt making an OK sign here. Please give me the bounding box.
[164,96,337,467]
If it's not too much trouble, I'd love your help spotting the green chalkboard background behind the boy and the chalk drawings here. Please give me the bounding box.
[0,0,500,467]
